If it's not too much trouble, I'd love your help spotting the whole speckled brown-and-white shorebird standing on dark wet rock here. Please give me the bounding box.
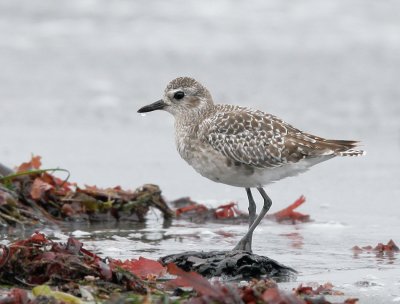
[138,77,364,252]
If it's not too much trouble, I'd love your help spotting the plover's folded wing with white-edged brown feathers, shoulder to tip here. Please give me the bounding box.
[199,105,356,168]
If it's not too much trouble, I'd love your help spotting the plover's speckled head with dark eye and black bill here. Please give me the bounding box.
[138,77,213,117]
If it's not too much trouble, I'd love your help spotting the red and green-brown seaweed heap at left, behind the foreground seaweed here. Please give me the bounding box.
[0,156,174,226]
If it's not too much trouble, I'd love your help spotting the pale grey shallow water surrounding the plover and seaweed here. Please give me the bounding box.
[0,0,400,303]
